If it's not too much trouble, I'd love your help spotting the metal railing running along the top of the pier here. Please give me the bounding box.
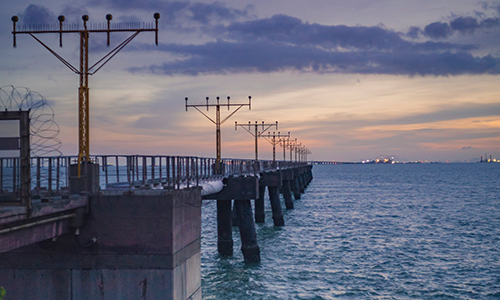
[0,155,305,201]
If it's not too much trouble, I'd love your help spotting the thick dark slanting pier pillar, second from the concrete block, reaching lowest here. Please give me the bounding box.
[234,200,260,263]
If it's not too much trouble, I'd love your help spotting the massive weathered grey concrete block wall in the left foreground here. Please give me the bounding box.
[0,188,201,300]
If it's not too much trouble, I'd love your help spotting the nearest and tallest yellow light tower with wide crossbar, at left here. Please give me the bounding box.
[12,13,160,176]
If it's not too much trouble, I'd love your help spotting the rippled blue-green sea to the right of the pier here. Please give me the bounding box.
[201,163,500,299]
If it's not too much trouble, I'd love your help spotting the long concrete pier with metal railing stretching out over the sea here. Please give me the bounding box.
[0,155,312,299]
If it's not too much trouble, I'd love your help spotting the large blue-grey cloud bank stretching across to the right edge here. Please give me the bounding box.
[124,9,500,76]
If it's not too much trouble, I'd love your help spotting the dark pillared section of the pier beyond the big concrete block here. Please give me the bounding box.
[204,165,312,263]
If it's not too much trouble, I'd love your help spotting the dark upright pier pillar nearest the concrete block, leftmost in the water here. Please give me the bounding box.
[217,200,233,256]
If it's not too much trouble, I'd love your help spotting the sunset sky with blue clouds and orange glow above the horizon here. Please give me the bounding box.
[0,0,500,161]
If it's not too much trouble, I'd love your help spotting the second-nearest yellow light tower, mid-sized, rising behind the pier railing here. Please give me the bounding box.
[185,96,252,174]
